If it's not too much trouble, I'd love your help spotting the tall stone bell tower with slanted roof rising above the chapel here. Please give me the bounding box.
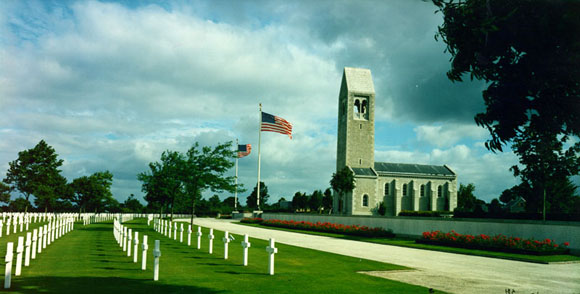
[336,67,375,171]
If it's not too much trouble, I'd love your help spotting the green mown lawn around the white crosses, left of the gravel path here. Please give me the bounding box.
[0,220,441,293]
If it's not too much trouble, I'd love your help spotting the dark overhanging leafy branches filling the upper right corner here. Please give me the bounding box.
[433,0,580,151]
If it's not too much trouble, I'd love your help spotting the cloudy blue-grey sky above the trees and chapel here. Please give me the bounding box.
[0,0,552,203]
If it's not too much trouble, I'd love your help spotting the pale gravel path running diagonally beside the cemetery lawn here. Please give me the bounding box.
[181,218,580,294]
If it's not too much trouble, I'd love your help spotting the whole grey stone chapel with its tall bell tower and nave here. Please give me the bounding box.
[333,67,457,216]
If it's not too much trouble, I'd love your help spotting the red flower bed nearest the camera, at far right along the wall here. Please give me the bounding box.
[417,231,570,255]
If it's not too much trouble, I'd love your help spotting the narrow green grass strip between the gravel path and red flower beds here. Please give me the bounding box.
[239,223,580,263]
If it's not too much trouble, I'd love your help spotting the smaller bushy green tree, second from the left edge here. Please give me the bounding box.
[70,171,114,213]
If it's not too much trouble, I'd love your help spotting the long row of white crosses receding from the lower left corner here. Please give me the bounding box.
[4,217,74,289]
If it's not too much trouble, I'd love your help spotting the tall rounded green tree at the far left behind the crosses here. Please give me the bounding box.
[3,140,66,211]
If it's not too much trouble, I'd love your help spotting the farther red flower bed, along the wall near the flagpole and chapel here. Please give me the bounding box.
[262,219,395,238]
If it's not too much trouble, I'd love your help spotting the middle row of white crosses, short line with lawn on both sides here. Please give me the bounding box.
[113,218,161,281]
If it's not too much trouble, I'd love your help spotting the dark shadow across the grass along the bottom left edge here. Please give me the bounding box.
[10,277,223,294]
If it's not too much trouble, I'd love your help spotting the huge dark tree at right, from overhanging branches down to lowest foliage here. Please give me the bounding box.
[433,0,580,216]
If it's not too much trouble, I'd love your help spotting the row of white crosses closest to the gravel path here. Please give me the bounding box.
[153,219,278,275]
